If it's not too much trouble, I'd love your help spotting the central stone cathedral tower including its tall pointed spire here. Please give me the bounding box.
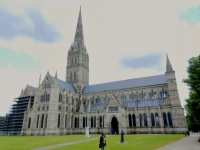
[66,8,89,93]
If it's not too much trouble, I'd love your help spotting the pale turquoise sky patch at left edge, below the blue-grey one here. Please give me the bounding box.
[0,48,43,69]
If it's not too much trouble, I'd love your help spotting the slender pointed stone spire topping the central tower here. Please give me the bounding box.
[74,6,84,50]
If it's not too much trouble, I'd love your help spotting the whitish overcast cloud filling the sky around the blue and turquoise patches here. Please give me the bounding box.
[0,0,200,115]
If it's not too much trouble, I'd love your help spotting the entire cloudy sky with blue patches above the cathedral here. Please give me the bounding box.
[0,0,200,116]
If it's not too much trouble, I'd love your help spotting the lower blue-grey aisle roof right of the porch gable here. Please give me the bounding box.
[122,98,165,108]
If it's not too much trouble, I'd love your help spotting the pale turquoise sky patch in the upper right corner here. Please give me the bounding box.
[179,5,200,26]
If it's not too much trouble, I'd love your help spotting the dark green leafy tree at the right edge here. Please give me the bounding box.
[183,55,200,130]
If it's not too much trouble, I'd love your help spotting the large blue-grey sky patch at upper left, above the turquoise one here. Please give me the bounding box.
[0,6,62,43]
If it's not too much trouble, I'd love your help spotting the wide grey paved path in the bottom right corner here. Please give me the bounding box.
[158,134,200,150]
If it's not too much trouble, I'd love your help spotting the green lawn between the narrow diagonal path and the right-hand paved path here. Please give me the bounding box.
[56,134,184,150]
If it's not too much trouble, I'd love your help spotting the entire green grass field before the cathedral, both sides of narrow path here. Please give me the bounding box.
[0,134,184,150]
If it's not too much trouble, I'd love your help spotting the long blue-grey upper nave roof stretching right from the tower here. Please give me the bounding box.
[83,74,167,94]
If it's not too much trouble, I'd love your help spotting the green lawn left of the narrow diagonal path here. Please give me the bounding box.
[0,135,99,150]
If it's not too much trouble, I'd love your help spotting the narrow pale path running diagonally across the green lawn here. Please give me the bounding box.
[34,137,99,150]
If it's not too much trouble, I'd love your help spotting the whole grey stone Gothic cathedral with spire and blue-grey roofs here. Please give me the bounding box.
[21,7,187,135]
